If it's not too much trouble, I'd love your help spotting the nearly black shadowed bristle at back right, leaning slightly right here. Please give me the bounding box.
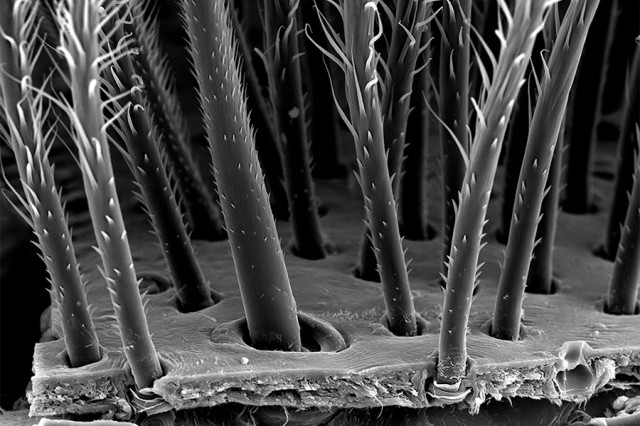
[562,0,618,214]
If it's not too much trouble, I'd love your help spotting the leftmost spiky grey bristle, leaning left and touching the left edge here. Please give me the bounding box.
[0,0,101,367]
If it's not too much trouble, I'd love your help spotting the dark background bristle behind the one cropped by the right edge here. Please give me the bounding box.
[598,49,640,260]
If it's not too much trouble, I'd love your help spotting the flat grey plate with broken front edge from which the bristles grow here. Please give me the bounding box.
[27,141,640,416]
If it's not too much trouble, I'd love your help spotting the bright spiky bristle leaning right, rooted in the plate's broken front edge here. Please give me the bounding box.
[436,0,551,386]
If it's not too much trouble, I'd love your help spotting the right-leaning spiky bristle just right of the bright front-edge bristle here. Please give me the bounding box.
[491,0,599,340]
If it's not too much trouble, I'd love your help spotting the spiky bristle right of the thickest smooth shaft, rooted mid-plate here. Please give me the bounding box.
[343,0,417,336]
